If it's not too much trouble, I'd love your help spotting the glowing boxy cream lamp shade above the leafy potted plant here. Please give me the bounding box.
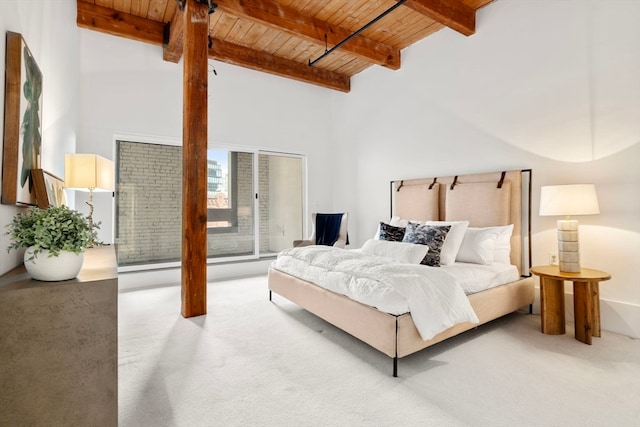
[64,154,114,191]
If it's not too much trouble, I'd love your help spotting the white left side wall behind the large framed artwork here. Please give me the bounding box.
[0,0,80,274]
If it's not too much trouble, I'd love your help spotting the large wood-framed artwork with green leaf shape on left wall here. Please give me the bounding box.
[1,31,42,205]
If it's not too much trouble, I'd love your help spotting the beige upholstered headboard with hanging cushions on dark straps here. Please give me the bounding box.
[391,169,531,276]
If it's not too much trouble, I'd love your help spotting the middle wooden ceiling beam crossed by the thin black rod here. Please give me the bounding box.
[216,0,400,70]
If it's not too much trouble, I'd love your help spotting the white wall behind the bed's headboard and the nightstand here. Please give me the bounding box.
[333,0,640,337]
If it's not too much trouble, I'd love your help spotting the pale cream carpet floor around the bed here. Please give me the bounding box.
[118,276,640,427]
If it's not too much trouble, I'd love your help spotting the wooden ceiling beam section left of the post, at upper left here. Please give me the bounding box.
[76,1,164,44]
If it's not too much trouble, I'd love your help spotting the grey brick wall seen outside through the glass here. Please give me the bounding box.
[116,141,269,266]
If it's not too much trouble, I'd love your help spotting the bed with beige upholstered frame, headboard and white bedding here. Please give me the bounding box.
[268,170,534,377]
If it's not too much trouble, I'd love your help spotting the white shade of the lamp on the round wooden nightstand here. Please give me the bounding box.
[540,184,600,216]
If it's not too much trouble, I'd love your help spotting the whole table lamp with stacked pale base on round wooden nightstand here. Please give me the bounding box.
[540,184,600,273]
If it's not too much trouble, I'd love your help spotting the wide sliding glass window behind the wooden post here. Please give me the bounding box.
[115,141,304,267]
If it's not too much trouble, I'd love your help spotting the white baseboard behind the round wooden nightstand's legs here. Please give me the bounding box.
[533,289,640,339]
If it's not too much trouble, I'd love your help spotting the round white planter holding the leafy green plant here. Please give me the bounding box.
[24,248,84,282]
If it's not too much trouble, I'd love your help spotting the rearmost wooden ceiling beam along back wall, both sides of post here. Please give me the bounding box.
[77,1,351,92]
